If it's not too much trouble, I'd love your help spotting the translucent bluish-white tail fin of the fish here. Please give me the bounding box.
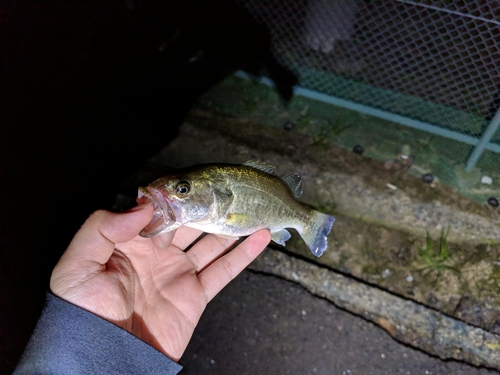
[300,211,335,257]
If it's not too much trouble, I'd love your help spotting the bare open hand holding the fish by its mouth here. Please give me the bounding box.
[50,205,271,361]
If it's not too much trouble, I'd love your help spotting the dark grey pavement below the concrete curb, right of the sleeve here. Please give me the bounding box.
[181,271,497,375]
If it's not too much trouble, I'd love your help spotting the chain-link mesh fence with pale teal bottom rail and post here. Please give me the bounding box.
[240,0,500,180]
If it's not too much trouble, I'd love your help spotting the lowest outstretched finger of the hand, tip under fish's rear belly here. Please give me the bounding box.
[198,229,271,303]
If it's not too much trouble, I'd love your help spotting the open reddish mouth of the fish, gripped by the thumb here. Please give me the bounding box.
[137,187,182,238]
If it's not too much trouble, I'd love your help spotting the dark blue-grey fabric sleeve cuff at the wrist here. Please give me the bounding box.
[14,293,182,375]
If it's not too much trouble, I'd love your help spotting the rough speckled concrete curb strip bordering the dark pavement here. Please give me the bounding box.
[249,248,500,370]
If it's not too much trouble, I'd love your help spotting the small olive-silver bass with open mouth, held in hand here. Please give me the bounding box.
[137,160,335,257]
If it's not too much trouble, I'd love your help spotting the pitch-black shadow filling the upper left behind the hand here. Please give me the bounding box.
[0,0,296,373]
